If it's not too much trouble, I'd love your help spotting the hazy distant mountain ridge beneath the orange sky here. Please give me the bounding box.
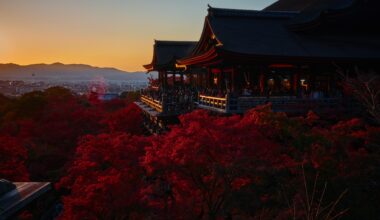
[0,63,153,81]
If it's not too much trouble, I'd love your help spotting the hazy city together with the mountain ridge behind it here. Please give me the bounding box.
[0,63,156,97]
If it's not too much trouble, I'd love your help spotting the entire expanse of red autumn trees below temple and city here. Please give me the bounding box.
[0,88,380,219]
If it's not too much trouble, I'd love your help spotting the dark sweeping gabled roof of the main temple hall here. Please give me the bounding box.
[178,4,380,65]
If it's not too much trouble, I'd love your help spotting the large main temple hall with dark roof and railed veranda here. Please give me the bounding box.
[137,0,380,132]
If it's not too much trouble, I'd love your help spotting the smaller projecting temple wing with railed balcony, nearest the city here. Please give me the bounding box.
[136,40,197,132]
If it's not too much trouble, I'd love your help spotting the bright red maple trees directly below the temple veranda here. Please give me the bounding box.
[58,106,380,219]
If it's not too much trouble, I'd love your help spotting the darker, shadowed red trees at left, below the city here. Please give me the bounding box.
[0,87,141,182]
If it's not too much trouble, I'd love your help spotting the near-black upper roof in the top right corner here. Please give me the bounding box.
[289,0,380,32]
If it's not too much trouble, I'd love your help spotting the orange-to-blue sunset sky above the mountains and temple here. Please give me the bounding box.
[0,0,275,71]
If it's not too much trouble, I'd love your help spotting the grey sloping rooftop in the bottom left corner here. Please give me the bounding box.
[0,181,52,220]
